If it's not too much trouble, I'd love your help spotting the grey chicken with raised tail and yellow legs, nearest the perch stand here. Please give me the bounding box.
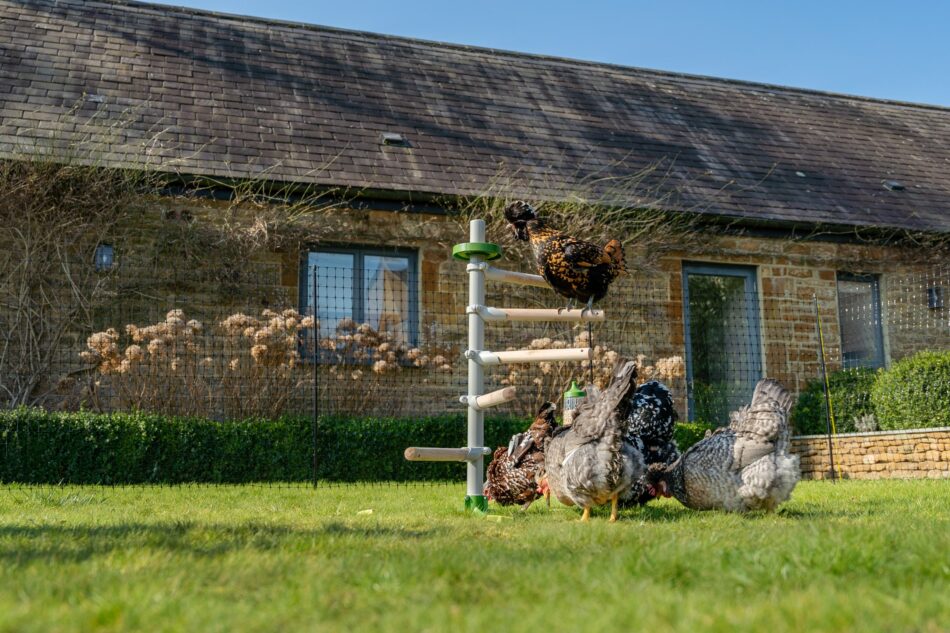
[540,362,646,522]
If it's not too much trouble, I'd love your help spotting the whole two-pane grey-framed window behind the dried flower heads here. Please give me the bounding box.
[300,248,419,345]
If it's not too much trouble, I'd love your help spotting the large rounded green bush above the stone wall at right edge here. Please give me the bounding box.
[871,351,950,430]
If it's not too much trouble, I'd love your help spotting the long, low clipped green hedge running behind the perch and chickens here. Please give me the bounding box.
[0,409,708,484]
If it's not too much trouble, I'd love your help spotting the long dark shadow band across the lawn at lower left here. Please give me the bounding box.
[0,521,444,564]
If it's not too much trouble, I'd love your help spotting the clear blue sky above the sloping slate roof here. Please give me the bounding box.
[152,0,950,106]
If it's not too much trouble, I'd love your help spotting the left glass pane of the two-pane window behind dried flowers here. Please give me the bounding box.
[304,253,355,338]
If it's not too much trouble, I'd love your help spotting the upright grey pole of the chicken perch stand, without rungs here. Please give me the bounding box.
[465,220,488,512]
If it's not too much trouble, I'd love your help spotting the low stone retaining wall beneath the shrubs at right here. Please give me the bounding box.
[791,427,950,479]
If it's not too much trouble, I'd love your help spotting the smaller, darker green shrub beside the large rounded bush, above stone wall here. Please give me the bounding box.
[792,368,877,435]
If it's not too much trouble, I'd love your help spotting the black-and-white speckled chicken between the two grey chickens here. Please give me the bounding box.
[620,380,680,507]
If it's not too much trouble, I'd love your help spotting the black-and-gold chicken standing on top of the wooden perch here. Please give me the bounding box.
[505,200,626,310]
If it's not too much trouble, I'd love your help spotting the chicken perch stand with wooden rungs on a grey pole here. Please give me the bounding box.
[405,220,604,512]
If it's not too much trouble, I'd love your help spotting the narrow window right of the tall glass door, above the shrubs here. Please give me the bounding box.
[838,273,884,369]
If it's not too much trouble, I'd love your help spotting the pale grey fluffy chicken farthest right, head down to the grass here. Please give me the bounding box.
[647,379,801,512]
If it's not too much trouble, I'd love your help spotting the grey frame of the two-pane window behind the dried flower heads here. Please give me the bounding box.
[297,244,420,354]
